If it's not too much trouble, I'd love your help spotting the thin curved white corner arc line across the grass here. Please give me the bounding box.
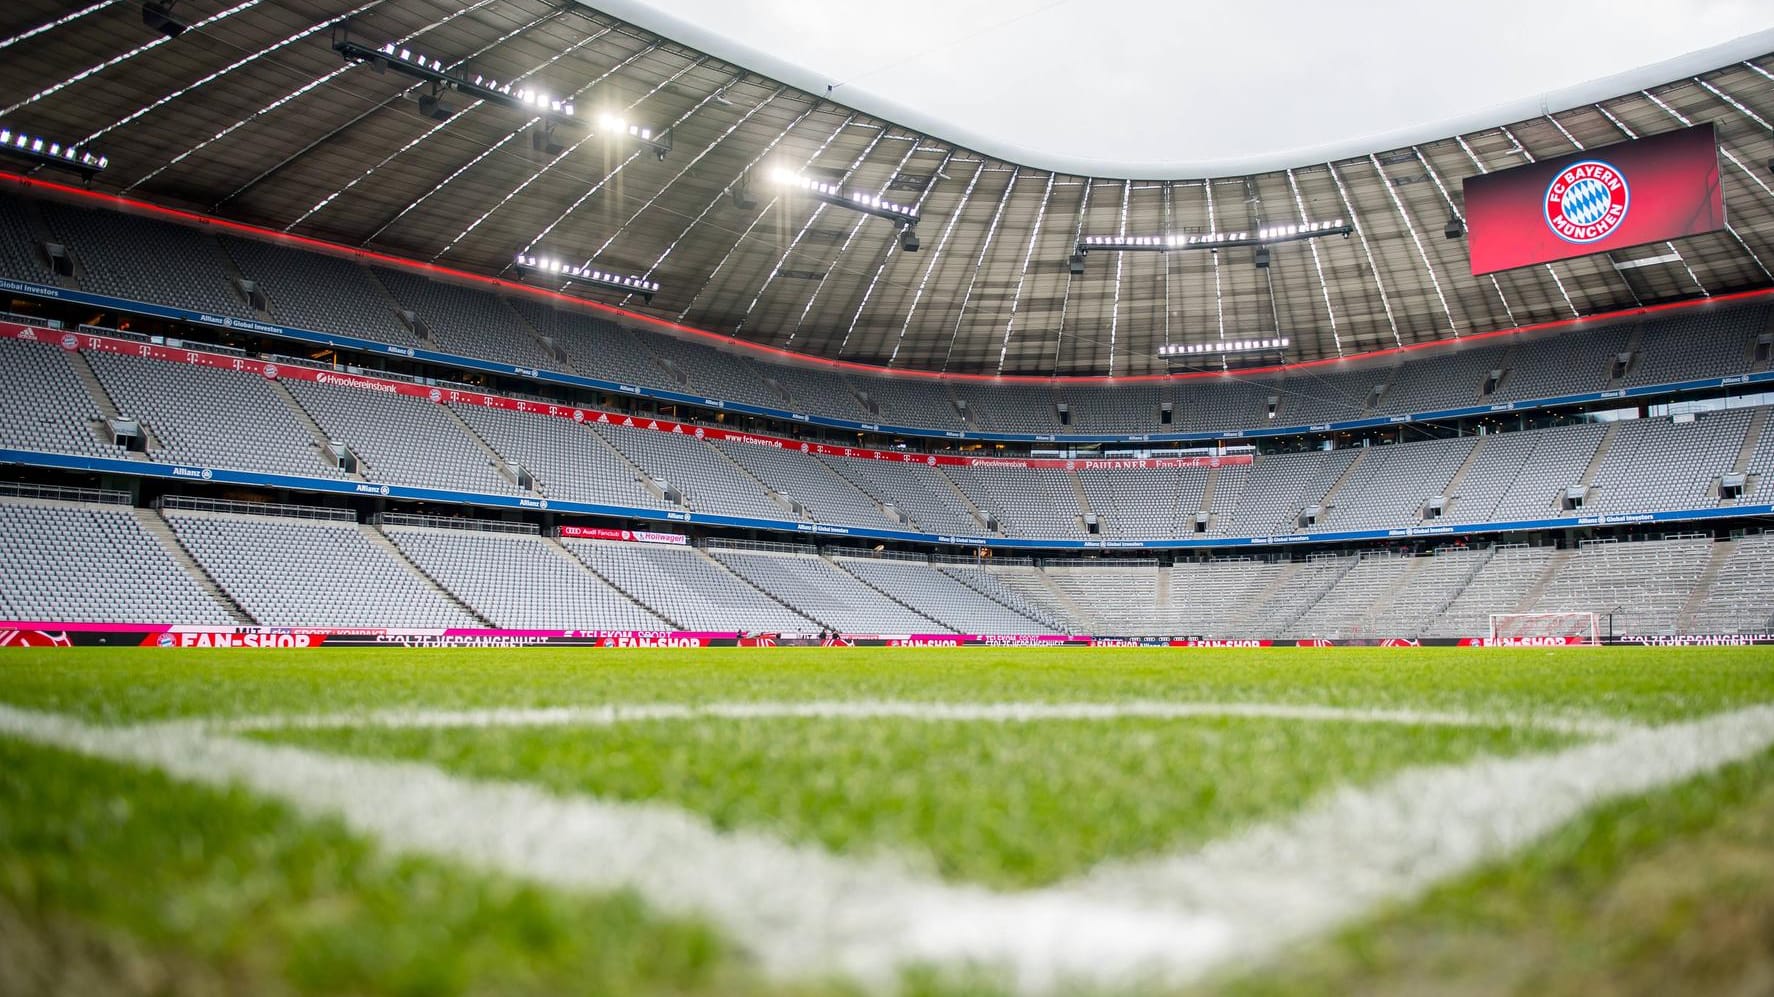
[204,699,1639,738]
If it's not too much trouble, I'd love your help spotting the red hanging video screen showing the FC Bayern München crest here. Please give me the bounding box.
[1464,124,1724,275]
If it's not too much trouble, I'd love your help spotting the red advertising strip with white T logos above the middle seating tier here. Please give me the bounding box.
[0,323,1252,471]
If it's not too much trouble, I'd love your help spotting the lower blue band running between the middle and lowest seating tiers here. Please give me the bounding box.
[0,447,1774,550]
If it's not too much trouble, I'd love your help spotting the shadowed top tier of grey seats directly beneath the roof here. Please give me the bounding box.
[0,199,1774,433]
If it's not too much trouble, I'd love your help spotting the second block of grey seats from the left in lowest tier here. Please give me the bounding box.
[167,511,481,628]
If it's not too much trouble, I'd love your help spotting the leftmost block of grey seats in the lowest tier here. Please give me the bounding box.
[0,499,236,626]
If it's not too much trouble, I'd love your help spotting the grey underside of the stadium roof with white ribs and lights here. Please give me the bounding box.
[0,0,1774,376]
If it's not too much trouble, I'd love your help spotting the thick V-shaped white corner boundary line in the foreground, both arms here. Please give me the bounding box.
[0,706,1774,992]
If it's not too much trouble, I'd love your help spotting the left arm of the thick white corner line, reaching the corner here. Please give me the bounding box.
[0,706,1229,988]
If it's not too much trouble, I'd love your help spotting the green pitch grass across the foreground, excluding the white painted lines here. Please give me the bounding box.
[0,648,1774,993]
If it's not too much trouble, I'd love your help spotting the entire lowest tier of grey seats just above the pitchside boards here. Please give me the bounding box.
[0,493,1774,640]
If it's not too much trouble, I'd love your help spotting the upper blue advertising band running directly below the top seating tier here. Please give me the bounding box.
[0,279,1774,444]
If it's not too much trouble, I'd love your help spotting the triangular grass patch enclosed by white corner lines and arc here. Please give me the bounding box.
[270,718,1566,889]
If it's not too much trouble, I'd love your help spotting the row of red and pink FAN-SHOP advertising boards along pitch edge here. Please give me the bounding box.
[0,621,1774,648]
